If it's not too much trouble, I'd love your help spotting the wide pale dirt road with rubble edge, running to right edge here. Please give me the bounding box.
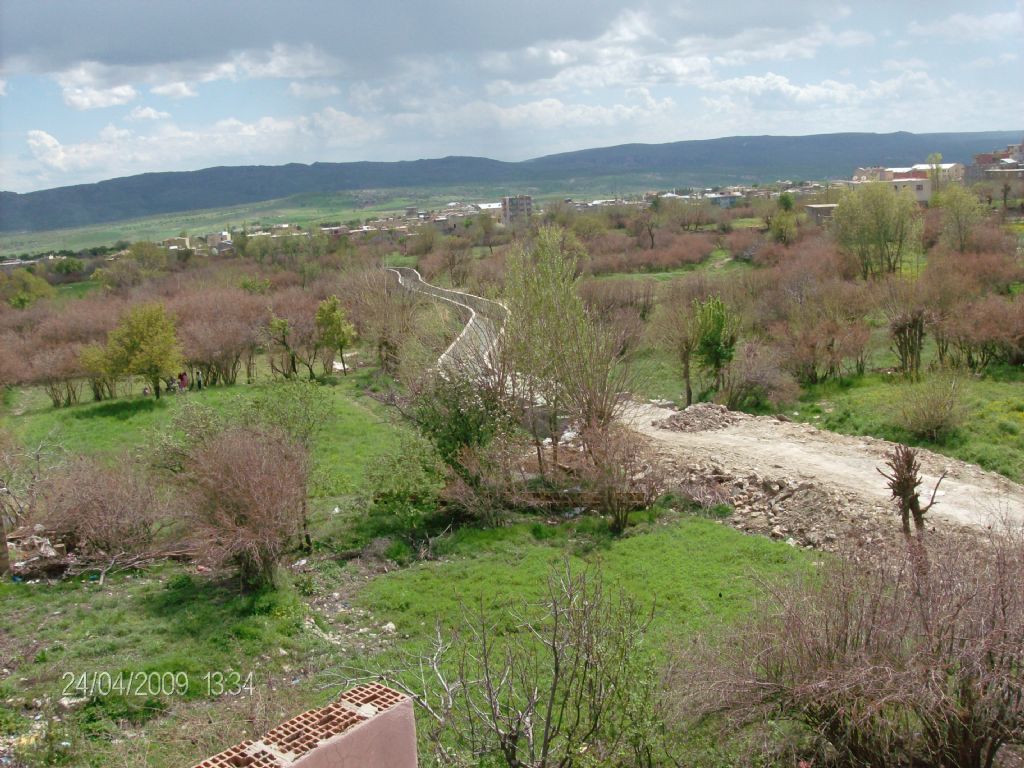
[628,404,1024,544]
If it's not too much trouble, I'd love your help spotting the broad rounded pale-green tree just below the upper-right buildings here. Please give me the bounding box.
[833,183,922,279]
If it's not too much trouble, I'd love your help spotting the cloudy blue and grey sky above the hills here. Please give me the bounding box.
[0,0,1024,191]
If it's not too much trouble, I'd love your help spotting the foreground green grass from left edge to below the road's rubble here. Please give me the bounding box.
[0,507,809,768]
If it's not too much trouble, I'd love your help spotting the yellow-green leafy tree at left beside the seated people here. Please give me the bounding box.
[106,302,181,398]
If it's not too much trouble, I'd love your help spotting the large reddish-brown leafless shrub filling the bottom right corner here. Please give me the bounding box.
[669,530,1024,768]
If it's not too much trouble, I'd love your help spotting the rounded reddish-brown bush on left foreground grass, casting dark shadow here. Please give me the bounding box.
[180,427,308,588]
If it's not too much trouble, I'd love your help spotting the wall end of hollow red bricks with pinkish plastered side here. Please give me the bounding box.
[193,683,417,768]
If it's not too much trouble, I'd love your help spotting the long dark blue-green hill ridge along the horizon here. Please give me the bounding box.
[0,130,1024,232]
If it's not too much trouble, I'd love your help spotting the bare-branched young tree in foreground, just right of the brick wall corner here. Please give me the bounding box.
[364,561,660,768]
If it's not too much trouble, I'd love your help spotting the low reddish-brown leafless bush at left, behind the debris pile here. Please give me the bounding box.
[42,458,164,561]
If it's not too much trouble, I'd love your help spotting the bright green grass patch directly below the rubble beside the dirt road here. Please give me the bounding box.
[360,518,804,645]
